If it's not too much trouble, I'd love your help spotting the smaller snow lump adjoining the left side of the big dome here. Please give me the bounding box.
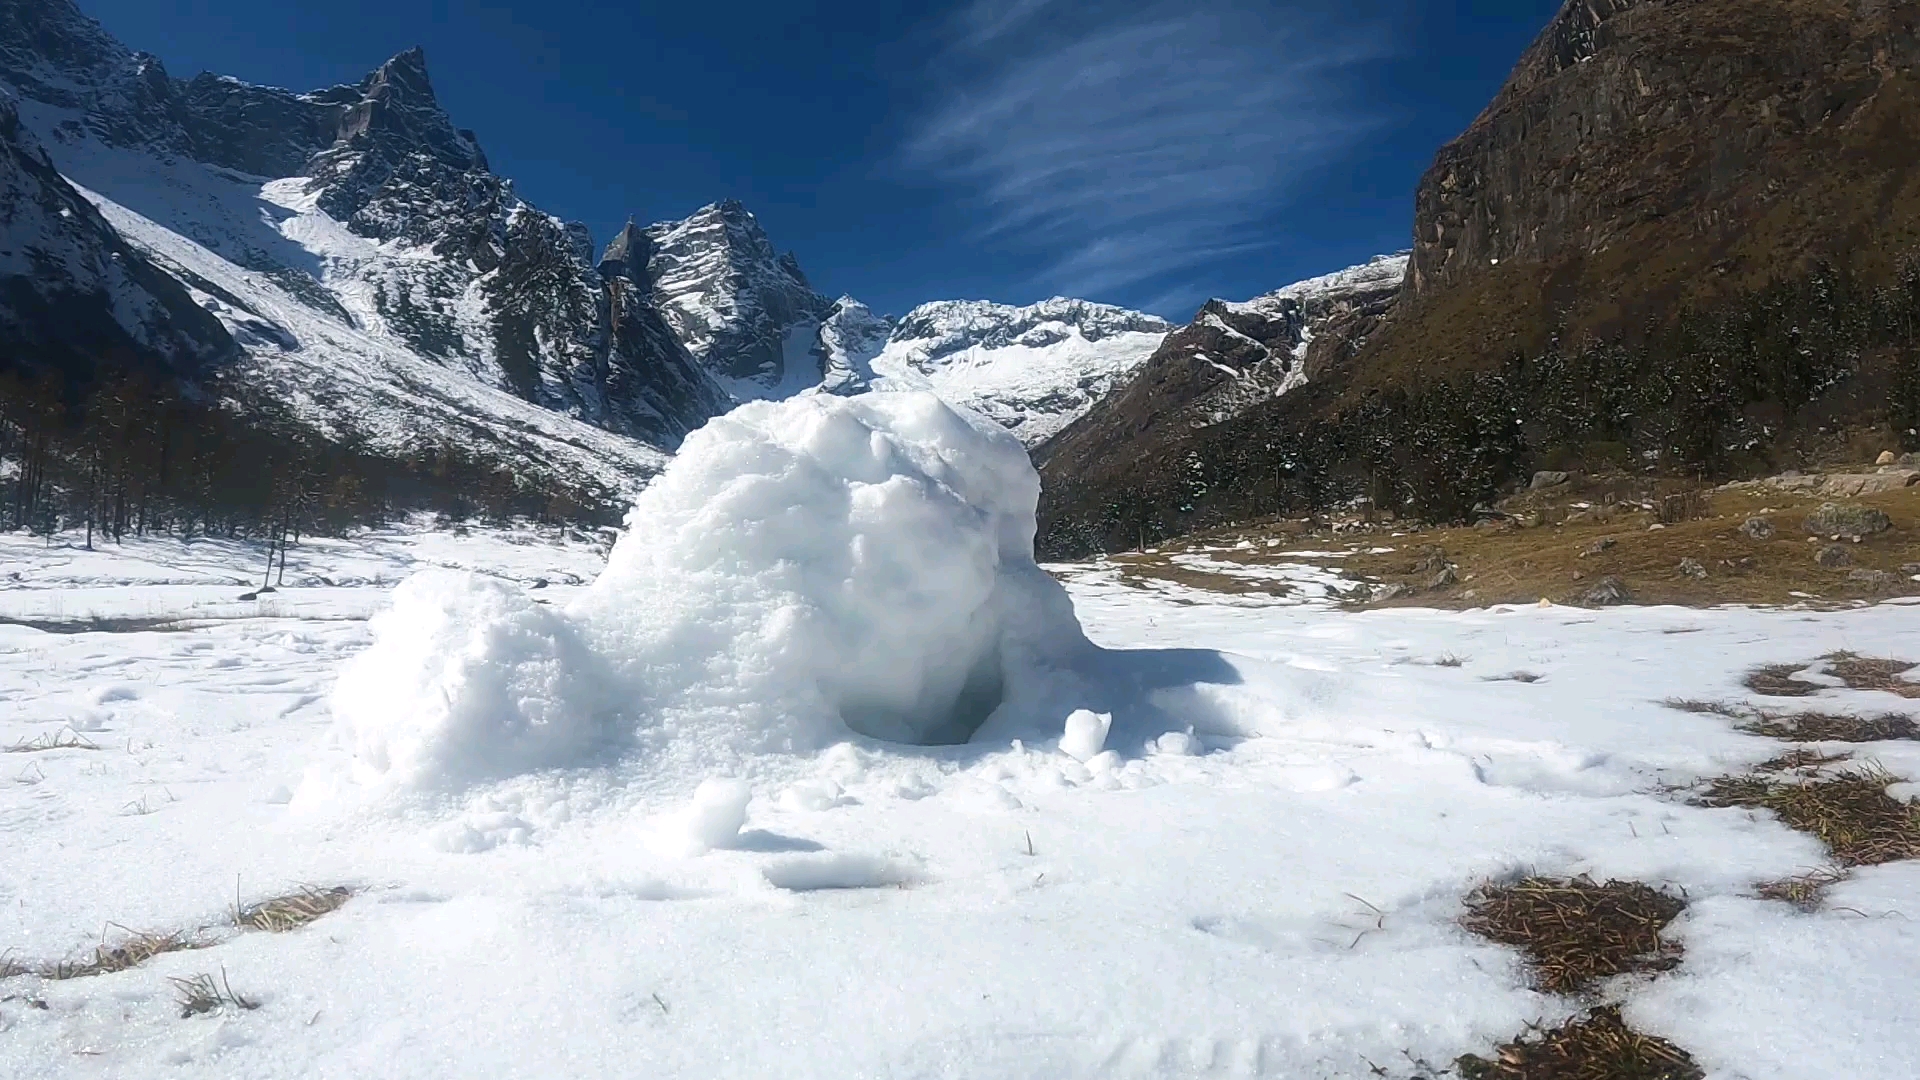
[332,571,618,788]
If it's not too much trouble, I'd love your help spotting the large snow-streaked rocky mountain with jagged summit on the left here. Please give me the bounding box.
[0,0,730,494]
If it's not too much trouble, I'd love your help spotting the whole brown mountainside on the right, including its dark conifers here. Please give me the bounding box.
[1041,0,1920,553]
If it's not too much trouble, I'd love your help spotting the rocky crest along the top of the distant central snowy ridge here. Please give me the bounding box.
[893,296,1173,361]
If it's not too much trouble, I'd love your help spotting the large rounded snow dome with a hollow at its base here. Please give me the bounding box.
[572,392,1091,751]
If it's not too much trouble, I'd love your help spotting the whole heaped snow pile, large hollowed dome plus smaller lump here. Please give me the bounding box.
[332,392,1092,788]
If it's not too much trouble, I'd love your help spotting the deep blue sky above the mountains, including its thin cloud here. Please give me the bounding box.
[81,0,1559,319]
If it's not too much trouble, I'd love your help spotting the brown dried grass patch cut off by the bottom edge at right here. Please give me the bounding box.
[1453,1005,1707,1080]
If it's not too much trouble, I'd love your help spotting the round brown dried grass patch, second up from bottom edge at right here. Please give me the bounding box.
[1461,876,1686,994]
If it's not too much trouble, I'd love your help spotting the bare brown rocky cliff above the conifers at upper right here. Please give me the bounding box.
[1371,0,1920,365]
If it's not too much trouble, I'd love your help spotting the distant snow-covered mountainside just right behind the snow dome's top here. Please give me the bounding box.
[860,296,1173,446]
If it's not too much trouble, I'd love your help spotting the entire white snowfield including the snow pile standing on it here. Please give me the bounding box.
[0,394,1920,1080]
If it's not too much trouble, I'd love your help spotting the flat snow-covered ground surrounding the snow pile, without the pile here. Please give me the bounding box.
[0,401,1920,1080]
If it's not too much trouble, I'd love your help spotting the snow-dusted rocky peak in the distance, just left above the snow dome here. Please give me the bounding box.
[645,198,833,390]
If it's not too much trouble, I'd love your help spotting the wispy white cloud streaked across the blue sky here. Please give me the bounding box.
[904,0,1392,311]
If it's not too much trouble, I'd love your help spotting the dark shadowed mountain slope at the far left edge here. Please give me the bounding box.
[0,94,236,379]
